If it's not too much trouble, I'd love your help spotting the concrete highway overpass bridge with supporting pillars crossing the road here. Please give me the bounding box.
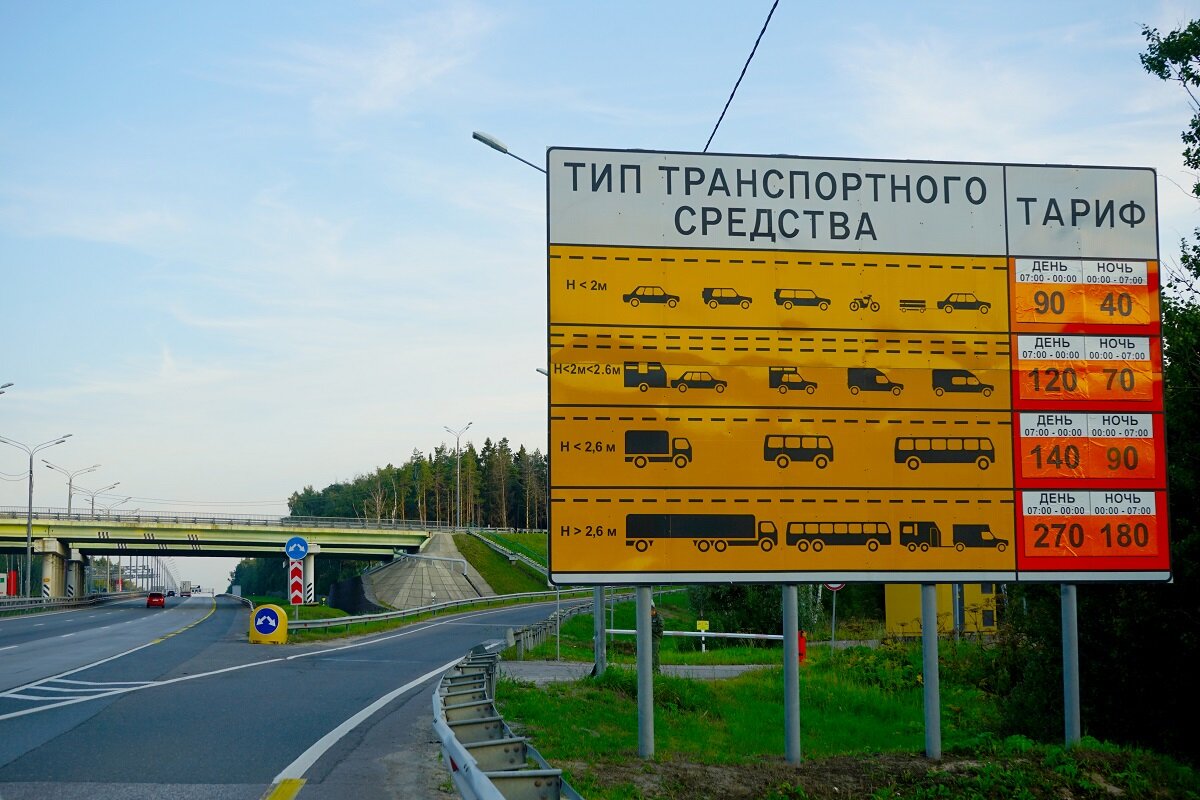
[0,507,441,597]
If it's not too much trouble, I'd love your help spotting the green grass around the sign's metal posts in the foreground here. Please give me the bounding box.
[497,643,1200,800]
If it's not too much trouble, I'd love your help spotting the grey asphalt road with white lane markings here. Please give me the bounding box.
[0,596,576,800]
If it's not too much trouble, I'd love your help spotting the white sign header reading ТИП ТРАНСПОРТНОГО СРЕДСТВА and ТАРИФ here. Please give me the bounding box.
[547,148,1157,258]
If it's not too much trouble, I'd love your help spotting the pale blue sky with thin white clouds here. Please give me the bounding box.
[0,0,1200,583]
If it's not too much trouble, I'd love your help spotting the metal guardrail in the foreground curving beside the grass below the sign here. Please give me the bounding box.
[433,645,583,800]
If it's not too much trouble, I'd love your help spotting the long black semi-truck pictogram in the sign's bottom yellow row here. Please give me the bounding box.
[625,513,779,553]
